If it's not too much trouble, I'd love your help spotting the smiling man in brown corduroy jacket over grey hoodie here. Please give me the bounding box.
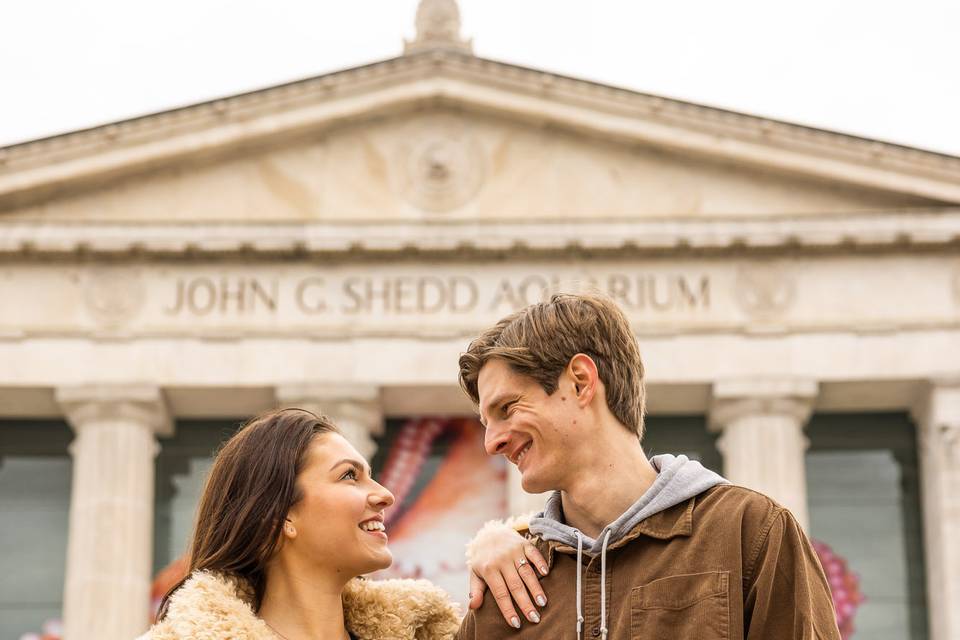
[458,295,840,640]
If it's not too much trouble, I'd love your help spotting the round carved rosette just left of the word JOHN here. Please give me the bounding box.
[83,267,146,328]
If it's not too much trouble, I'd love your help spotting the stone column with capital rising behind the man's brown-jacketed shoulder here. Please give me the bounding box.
[710,379,817,529]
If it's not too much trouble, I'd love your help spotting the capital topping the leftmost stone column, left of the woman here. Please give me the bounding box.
[55,385,174,436]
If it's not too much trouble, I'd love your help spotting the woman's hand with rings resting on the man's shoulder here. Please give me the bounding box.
[467,520,547,629]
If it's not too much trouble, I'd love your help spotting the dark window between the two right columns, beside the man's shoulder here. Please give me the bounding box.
[807,413,927,640]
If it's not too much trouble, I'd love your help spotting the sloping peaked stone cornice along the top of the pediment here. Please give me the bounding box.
[0,49,960,209]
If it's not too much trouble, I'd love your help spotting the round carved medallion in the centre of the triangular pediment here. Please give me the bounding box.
[400,121,485,213]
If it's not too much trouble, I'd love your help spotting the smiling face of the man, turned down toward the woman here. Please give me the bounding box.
[477,359,586,493]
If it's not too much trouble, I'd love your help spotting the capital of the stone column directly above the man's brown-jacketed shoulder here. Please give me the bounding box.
[709,377,819,431]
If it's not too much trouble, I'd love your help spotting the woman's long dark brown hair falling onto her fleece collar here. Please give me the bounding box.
[157,409,339,620]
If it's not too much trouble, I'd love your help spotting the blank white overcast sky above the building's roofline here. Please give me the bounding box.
[0,0,960,156]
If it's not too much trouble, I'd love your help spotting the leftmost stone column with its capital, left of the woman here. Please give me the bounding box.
[56,386,173,640]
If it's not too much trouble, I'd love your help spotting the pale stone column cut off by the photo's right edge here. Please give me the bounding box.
[913,378,960,640]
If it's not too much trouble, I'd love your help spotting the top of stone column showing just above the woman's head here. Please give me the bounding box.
[276,384,384,462]
